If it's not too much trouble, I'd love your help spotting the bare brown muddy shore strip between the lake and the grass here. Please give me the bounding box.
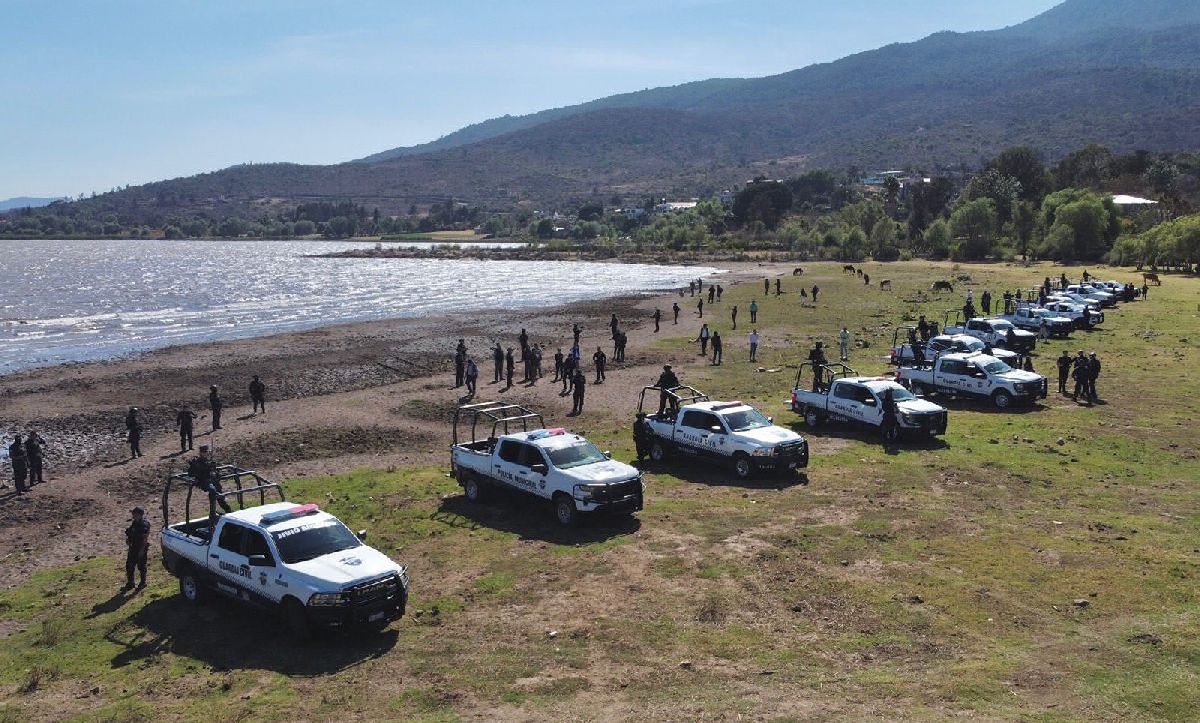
[0,263,777,588]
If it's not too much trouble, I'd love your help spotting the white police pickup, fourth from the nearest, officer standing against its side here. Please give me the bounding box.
[792,362,947,441]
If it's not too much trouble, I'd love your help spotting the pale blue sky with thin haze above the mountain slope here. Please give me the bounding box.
[0,0,1060,199]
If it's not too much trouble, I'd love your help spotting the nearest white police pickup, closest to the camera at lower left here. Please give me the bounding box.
[160,465,408,635]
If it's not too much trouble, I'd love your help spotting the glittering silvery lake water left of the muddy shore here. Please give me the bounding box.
[0,240,718,374]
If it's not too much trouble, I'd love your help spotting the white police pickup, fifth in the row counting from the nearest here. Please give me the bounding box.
[895,353,1046,410]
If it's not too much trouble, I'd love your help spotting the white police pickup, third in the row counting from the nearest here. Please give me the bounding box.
[638,387,809,479]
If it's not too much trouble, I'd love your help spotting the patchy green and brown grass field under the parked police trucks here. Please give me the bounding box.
[0,262,1200,722]
